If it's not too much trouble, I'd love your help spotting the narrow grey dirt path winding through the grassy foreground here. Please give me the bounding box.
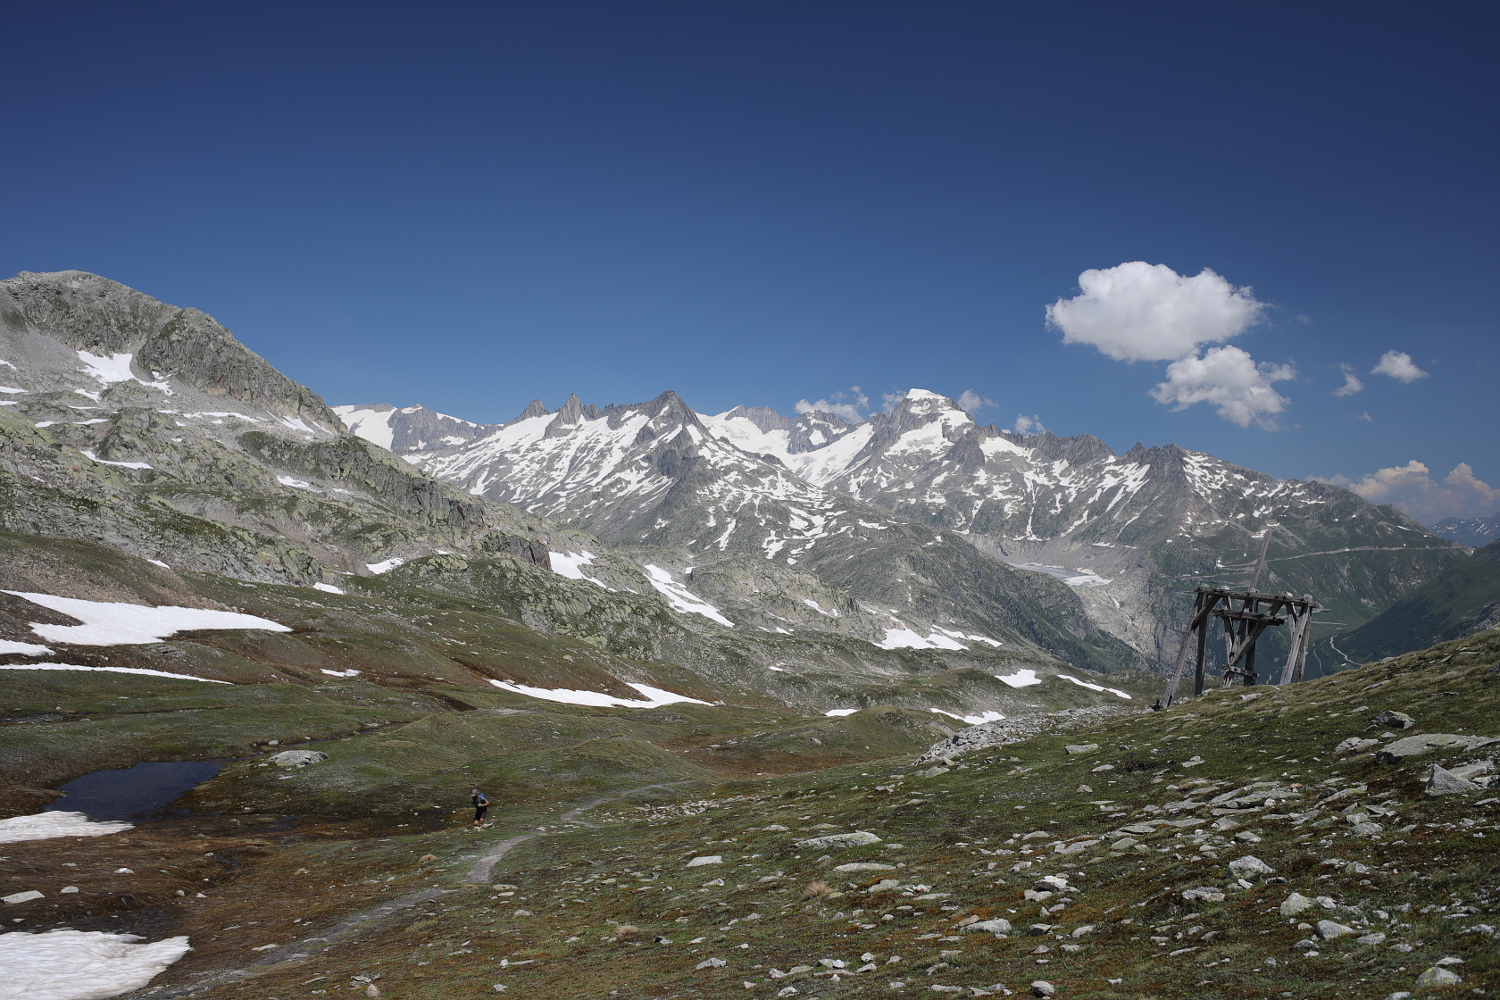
[141,781,690,1000]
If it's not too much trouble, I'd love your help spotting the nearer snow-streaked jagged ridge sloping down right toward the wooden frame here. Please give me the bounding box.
[384,391,1136,666]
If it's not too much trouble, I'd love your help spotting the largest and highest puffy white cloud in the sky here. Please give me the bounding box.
[1047,261,1265,361]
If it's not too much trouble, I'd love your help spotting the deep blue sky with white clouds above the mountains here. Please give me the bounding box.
[0,0,1500,520]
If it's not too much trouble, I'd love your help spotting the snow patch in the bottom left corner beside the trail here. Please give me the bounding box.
[0,928,192,1000]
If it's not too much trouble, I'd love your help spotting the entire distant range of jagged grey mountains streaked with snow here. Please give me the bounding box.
[348,388,1458,660]
